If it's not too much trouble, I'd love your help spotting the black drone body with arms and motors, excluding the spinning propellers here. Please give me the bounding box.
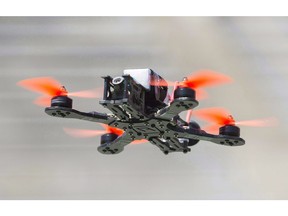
[45,69,245,154]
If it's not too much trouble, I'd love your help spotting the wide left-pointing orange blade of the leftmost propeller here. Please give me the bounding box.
[17,77,67,97]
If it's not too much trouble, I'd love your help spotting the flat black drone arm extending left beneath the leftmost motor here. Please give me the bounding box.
[45,106,116,124]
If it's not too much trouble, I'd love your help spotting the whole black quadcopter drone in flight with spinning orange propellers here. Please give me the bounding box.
[18,69,274,155]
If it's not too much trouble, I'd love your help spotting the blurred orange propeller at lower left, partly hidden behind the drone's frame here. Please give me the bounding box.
[64,124,148,144]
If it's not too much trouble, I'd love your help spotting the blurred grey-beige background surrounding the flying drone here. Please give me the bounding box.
[0,17,288,199]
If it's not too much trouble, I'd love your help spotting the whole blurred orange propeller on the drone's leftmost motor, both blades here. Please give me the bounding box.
[17,77,102,106]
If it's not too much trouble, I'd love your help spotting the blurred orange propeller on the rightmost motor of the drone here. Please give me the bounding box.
[190,107,278,132]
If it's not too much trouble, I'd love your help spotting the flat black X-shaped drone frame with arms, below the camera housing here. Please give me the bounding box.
[45,90,245,154]
